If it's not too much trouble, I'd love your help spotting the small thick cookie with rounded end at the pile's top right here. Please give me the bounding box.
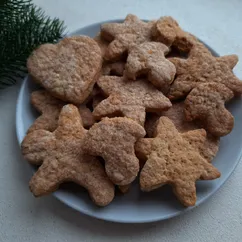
[152,16,198,52]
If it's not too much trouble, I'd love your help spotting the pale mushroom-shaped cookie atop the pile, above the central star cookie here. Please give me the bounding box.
[125,42,176,92]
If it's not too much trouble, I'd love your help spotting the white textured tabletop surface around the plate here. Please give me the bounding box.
[0,0,242,242]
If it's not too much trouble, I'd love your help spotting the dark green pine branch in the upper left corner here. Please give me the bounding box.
[0,0,65,89]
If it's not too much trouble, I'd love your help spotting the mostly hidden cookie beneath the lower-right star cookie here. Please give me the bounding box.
[145,102,220,162]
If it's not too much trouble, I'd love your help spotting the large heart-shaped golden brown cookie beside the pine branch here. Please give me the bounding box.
[27,36,102,104]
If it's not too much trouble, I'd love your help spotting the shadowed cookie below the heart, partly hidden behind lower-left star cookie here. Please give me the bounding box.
[28,90,95,132]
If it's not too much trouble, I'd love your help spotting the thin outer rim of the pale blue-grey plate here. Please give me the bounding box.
[15,19,242,224]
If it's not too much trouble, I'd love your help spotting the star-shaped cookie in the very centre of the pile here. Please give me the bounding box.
[93,76,171,125]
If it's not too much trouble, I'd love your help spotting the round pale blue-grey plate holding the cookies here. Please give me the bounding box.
[16,20,242,223]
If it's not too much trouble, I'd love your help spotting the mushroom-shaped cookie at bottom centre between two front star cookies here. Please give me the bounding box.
[84,117,145,185]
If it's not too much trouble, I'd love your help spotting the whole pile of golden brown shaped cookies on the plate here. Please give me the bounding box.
[22,15,242,206]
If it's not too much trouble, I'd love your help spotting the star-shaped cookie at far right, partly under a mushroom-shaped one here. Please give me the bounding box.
[169,47,242,100]
